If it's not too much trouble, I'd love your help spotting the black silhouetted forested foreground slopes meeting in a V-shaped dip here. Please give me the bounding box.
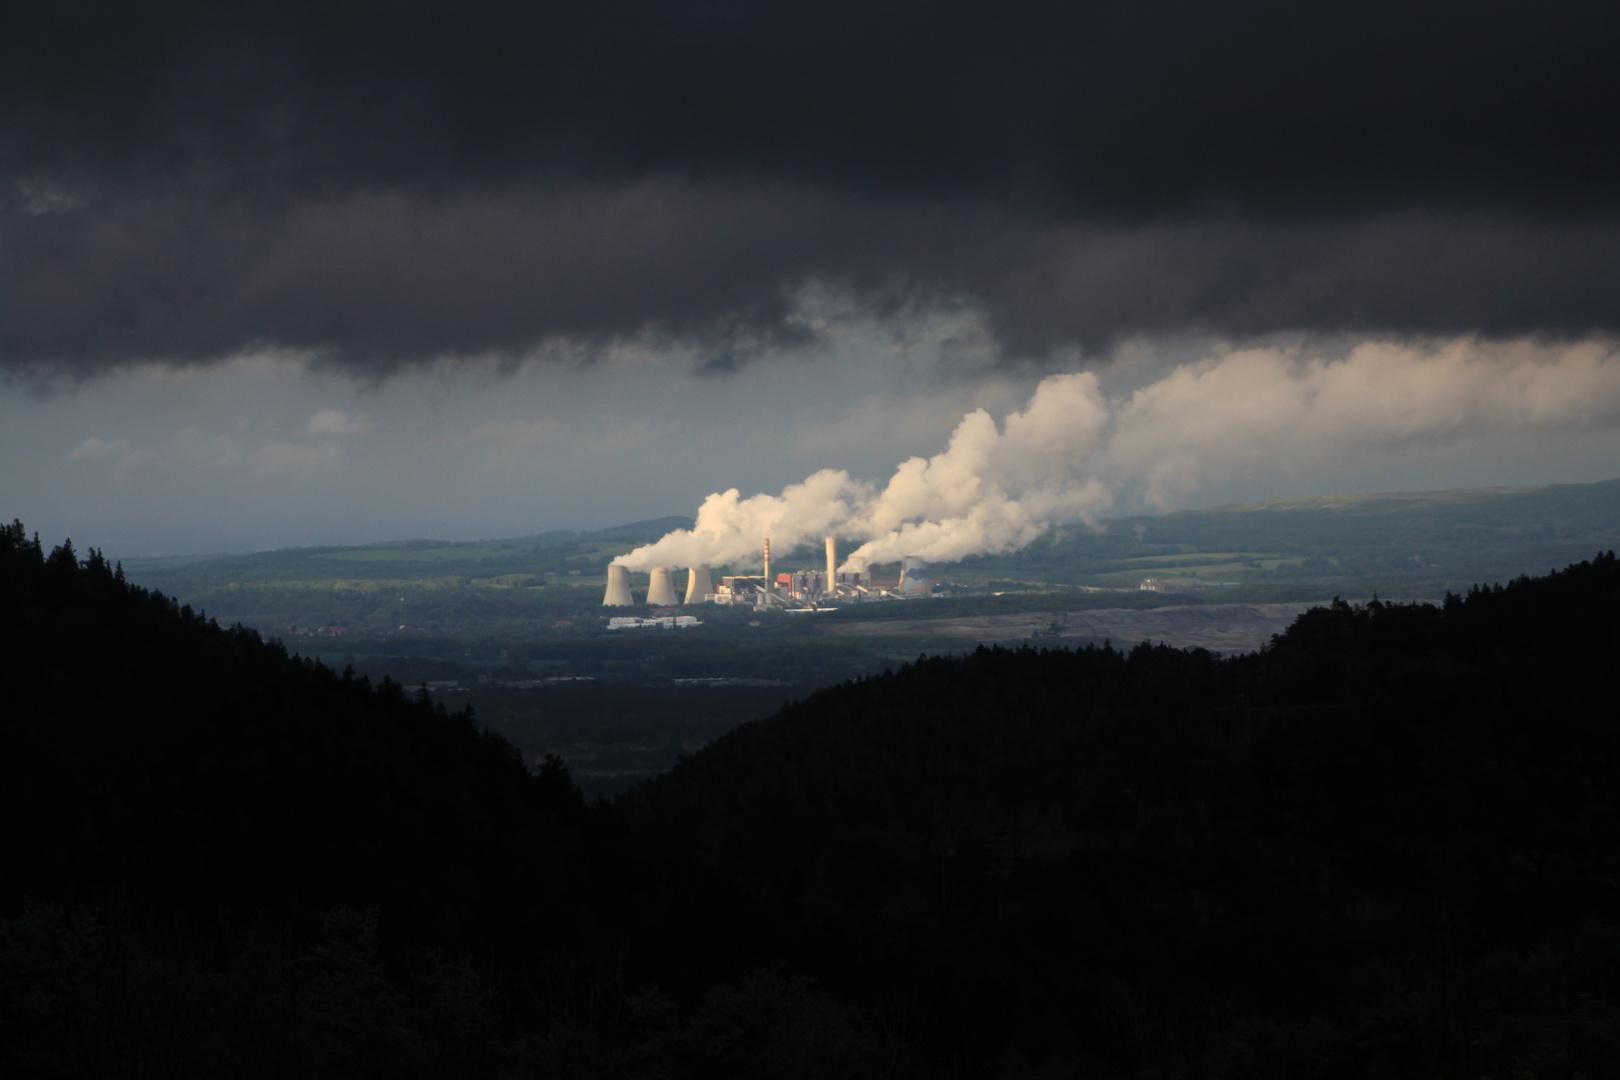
[0,525,1620,1078]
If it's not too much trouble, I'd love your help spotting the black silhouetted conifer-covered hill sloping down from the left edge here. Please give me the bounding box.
[0,523,764,1077]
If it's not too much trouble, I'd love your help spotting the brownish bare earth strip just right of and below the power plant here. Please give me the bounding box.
[821,601,1439,654]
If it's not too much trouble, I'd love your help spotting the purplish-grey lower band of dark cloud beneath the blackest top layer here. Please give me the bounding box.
[12,178,1620,379]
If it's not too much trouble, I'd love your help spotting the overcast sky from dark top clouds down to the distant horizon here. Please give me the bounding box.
[0,0,1620,555]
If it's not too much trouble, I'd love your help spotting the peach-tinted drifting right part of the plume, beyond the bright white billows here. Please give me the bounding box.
[1095,338,1620,510]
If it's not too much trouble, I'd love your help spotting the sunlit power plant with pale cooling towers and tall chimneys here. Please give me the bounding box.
[603,536,933,612]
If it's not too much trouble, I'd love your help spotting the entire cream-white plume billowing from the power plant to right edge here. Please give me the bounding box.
[617,338,1620,570]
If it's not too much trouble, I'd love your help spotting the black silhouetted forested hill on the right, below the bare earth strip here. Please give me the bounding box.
[622,554,1620,1077]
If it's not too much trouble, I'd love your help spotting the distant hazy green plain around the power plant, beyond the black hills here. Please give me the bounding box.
[125,481,1620,792]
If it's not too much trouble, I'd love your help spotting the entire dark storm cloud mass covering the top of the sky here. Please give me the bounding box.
[0,2,1620,368]
